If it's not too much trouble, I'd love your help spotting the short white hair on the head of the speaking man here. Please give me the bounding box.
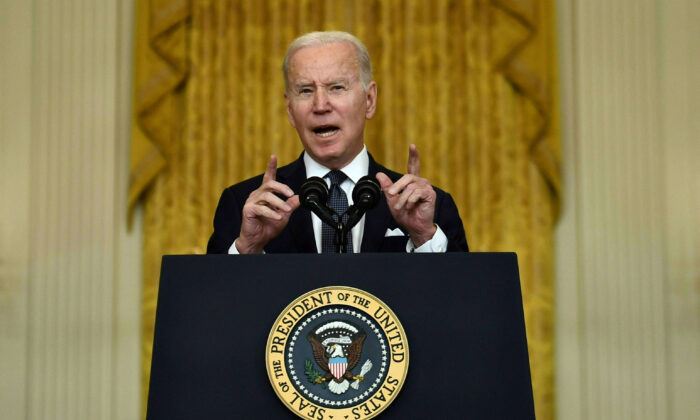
[282,31,372,90]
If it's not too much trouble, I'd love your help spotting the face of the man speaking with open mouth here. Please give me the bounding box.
[284,42,377,169]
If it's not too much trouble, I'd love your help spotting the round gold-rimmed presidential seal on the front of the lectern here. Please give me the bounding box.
[265,286,408,420]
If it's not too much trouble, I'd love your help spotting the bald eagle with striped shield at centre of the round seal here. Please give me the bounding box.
[306,321,372,395]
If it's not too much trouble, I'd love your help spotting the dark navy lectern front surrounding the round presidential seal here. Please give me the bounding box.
[147,253,535,420]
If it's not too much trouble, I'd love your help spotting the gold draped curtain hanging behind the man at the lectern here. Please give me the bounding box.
[130,0,560,420]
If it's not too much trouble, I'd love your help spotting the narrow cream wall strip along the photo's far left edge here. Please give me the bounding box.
[0,0,32,419]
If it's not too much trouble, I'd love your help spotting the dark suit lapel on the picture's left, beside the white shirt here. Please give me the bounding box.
[277,154,317,253]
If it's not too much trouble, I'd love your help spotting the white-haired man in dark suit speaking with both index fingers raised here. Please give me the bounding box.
[207,32,468,254]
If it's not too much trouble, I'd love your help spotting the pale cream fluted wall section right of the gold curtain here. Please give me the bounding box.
[556,0,700,420]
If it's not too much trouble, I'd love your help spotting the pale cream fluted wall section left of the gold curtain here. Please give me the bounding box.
[0,0,141,420]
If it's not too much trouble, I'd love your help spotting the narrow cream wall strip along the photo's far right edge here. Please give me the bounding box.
[659,0,700,419]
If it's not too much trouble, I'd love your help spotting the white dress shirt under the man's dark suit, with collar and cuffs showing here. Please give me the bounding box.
[228,146,447,254]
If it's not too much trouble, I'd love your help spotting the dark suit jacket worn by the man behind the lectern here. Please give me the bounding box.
[207,155,469,254]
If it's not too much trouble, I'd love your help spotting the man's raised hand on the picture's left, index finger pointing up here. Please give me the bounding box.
[236,155,299,254]
